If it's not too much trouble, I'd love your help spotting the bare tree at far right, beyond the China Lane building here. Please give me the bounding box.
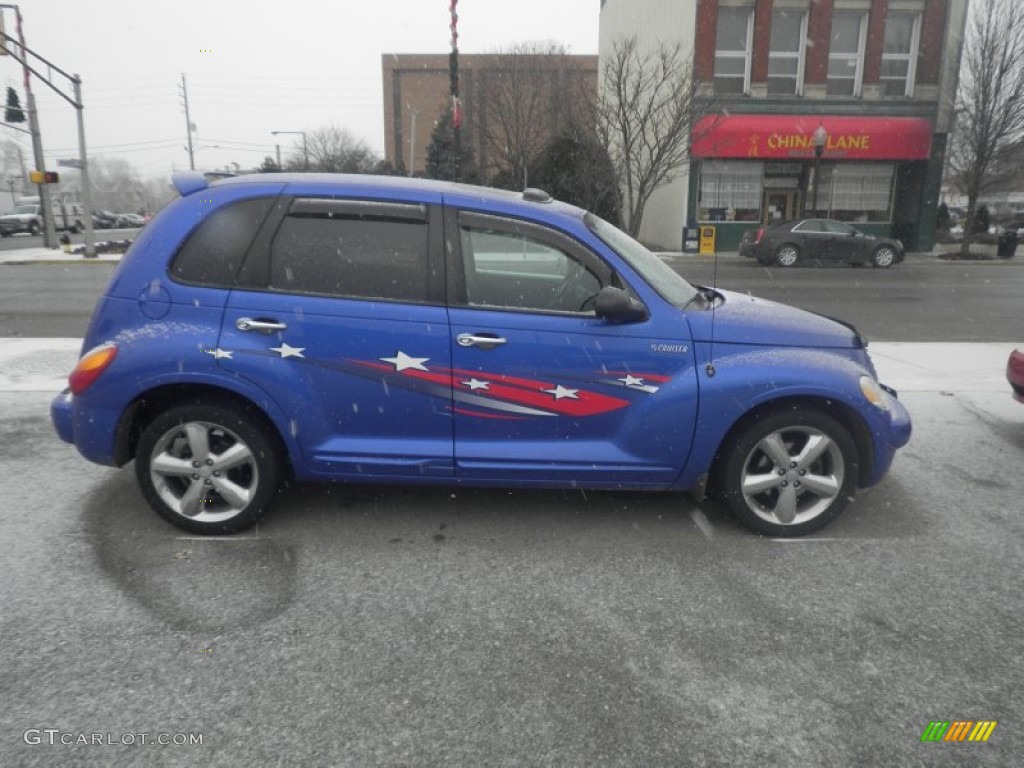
[948,0,1024,254]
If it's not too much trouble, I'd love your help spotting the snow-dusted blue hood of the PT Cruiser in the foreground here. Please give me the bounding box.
[686,289,867,349]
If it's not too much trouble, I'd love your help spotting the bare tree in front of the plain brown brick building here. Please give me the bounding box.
[483,43,579,186]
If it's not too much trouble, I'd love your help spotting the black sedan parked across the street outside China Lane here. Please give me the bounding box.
[739,219,904,267]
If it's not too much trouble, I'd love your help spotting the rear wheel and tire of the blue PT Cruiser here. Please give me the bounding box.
[135,402,283,535]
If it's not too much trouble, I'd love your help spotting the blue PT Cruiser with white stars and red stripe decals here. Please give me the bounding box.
[51,173,911,537]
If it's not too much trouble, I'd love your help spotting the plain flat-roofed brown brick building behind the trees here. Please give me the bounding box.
[381,53,597,177]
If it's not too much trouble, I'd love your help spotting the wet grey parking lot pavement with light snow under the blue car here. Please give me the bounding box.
[0,339,1024,766]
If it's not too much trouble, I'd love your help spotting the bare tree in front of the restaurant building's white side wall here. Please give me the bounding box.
[597,37,697,237]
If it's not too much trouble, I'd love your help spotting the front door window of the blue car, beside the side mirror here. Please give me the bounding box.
[460,224,601,312]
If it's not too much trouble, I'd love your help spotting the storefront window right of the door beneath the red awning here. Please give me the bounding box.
[817,163,895,221]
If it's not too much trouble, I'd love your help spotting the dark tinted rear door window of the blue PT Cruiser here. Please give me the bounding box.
[270,200,428,302]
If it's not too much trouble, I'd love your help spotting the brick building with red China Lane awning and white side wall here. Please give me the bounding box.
[601,0,968,250]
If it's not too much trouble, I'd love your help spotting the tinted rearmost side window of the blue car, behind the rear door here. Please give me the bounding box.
[171,198,274,288]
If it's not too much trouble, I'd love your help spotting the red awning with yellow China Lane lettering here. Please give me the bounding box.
[690,115,932,160]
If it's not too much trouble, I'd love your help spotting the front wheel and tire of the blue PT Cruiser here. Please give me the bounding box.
[718,409,859,538]
